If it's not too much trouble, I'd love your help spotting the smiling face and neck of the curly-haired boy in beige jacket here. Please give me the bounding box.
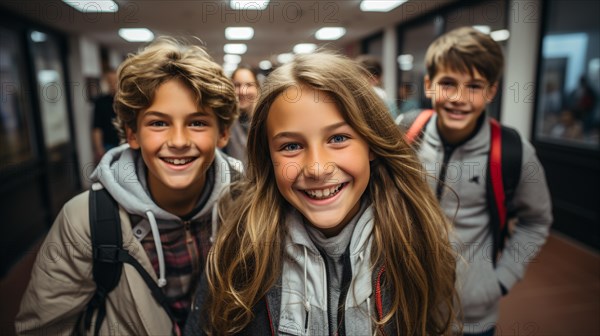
[127,79,228,215]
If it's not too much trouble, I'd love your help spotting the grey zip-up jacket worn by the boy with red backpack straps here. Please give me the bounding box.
[404,115,552,333]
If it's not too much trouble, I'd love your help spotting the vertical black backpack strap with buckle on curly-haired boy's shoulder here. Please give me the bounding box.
[84,189,123,335]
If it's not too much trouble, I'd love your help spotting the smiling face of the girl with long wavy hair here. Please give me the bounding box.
[267,86,372,236]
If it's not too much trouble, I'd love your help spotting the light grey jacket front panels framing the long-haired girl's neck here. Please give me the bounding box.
[279,204,374,335]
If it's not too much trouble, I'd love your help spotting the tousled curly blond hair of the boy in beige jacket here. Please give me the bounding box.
[114,36,238,141]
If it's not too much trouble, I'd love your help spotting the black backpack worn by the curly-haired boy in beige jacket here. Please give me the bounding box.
[79,158,242,335]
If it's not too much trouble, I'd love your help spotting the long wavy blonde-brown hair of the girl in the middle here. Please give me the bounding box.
[204,52,456,335]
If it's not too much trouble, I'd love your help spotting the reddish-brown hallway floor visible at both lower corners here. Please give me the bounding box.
[0,233,600,336]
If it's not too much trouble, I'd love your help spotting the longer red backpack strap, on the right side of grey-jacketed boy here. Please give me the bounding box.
[489,119,506,232]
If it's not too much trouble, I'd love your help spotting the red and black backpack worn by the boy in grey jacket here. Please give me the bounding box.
[401,110,523,266]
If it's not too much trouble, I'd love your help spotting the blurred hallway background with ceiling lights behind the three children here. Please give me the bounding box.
[0,0,600,335]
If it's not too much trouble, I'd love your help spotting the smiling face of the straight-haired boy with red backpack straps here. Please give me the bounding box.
[425,68,497,143]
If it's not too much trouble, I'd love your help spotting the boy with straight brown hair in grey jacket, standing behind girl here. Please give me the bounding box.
[396,27,552,336]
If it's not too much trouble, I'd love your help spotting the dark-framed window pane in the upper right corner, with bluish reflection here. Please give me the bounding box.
[535,1,600,150]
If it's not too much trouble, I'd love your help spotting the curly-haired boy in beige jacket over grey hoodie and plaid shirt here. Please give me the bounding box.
[16,38,241,335]
